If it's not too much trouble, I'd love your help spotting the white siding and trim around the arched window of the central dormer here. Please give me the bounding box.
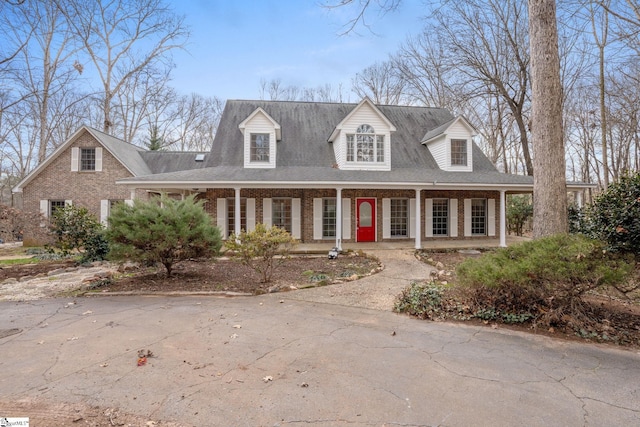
[330,98,396,171]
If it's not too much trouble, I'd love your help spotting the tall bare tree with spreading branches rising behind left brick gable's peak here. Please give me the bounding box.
[55,0,188,133]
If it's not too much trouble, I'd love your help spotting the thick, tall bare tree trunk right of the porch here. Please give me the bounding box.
[529,0,569,238]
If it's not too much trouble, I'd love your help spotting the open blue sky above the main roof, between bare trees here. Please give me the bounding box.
[169,0,425,101]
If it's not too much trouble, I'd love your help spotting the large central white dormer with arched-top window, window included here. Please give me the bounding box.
[329,98,396,171]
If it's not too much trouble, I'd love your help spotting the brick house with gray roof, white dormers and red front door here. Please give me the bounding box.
[14,98,579,248]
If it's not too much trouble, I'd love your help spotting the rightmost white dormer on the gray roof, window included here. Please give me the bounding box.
[421,116,478,172]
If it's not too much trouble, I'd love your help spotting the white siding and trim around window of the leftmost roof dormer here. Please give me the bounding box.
[238,108,280,169]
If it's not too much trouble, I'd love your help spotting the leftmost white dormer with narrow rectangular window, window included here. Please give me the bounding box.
[238,107,282,169]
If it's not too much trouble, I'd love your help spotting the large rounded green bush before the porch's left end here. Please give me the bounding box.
[107,196,222,276]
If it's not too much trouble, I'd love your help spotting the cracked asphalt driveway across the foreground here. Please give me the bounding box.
[0,249,640,426]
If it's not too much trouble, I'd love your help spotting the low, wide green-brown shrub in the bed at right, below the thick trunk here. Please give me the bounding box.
[457,235,634,326]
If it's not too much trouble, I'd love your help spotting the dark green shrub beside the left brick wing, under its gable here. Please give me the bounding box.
[49,205,109,262]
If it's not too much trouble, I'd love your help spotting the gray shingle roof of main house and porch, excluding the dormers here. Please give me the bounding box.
[117,100,533,186]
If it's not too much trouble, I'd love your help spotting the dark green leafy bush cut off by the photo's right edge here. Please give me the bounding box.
[582,173,640,254]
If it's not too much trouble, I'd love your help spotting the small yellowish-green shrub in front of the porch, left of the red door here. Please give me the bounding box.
[225,224,296,283]
